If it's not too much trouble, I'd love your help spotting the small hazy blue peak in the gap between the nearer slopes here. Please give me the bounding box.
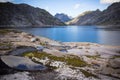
[55,13,72,22]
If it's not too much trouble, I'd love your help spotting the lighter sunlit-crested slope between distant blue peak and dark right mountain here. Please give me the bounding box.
[67,10,101,25]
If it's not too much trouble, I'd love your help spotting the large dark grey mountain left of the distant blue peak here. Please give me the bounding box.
[0,2,65,26]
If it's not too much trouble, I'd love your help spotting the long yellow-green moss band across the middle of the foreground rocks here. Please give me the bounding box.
[23,52,87,67]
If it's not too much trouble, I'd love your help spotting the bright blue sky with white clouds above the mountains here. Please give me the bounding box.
[0,0,120,17]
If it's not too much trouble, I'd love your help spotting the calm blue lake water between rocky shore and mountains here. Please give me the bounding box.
[18,26,120,45]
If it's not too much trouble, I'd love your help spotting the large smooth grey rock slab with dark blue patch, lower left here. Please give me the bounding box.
[1,56,47,71]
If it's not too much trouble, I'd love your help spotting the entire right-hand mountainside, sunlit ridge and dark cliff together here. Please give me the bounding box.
[67,2,120,25]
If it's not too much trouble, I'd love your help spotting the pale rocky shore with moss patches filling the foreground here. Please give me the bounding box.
[0,29,120,80]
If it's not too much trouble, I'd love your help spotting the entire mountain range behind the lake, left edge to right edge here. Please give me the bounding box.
[0,2,120,27]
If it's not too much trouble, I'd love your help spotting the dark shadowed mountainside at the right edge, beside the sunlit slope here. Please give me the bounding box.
[96,2,120,25]
